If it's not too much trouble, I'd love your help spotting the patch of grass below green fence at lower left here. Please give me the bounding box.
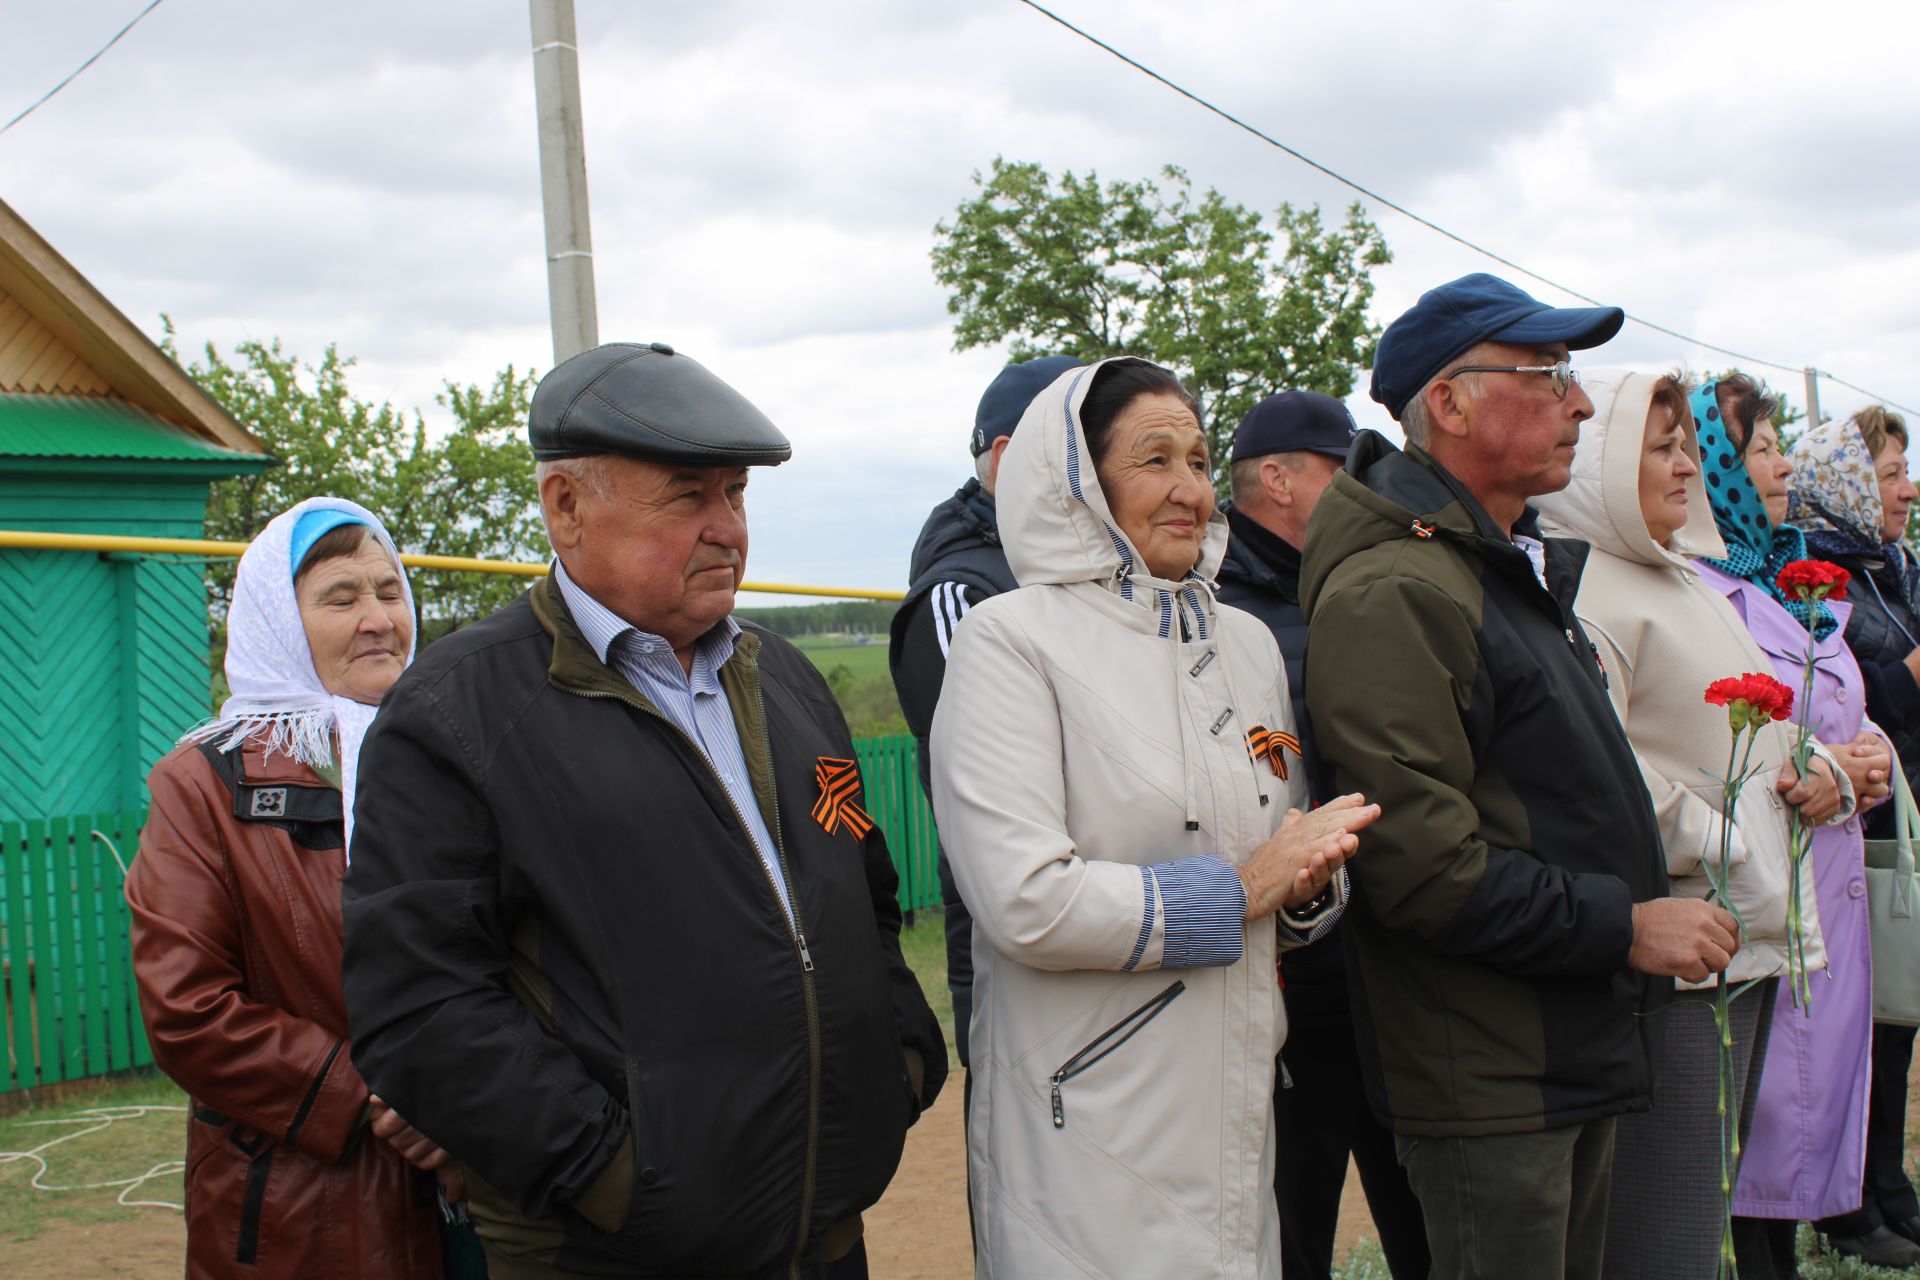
[0,1073,186,1240]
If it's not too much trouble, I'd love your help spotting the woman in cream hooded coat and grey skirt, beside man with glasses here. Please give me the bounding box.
[1536,368,1853,1280]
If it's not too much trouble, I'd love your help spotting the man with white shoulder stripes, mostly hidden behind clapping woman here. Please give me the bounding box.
[887,355,1083,1067]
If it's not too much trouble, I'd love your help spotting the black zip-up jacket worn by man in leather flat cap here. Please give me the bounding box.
[344,578,947,1276]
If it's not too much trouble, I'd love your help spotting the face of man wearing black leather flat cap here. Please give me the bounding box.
[543,457,747,649]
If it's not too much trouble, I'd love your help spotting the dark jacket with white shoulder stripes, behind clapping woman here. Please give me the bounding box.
[887,480,1020,1065]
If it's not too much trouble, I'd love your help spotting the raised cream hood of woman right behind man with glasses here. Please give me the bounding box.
[1534,368,1726,572]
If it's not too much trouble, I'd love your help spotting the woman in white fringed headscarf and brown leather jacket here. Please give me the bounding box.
[127,497,463,1278]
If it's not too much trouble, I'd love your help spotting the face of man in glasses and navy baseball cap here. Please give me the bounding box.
[1457,342,1594,497]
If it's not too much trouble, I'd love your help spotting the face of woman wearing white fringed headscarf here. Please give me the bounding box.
[294,537,413,706]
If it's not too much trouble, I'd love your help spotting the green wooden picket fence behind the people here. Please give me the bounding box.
[0,735,941,1094]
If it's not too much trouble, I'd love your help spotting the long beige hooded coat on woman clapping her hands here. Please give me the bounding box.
[931,358,1344,1280]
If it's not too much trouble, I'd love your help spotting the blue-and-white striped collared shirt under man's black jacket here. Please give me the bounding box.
[553,560,793,921]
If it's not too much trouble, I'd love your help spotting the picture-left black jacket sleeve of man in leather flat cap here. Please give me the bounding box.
[342,679,632,1221]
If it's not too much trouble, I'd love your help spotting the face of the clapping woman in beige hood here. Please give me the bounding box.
[1094,391,1213,578]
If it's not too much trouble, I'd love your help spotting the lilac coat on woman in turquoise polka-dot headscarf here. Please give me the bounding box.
[1699,564,1878,1219]
